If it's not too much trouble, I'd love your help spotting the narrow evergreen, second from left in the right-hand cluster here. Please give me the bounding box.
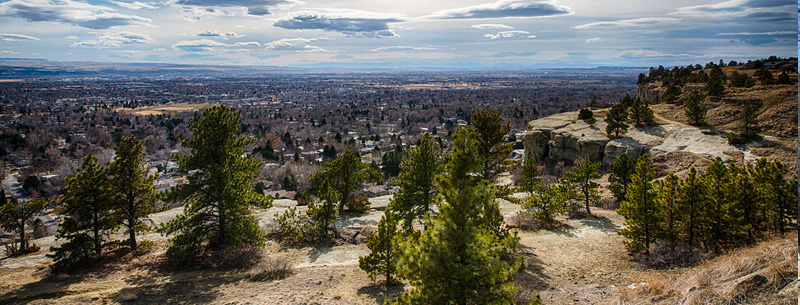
[656,173,681,252]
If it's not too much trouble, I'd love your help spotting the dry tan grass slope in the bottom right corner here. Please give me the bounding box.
[615,233,798,304]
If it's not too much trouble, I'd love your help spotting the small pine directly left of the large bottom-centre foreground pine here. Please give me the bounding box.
[358,209,399,287]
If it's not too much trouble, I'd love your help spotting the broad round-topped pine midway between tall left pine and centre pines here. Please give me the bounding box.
[307,148,380,213]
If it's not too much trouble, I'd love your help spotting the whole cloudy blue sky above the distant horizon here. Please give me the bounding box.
[0,0,798,69]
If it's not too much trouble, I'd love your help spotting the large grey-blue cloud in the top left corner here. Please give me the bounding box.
[0,0,152,29]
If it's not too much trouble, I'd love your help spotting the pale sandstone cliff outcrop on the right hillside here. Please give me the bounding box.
[523,110,752,166]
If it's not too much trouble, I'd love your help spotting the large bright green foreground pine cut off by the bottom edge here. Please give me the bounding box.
[394,128,523,304]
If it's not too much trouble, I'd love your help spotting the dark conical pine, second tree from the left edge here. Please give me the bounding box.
[48,154,119,271]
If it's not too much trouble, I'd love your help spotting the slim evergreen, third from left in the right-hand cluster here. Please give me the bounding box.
[678,166,704,245]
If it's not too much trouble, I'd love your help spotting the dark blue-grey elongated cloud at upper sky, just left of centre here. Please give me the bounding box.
[274,10,402,38]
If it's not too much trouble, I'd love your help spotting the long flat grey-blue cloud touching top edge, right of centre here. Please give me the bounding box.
[427,0,573,19]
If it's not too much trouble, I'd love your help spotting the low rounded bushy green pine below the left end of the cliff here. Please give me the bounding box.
[522,179,578,222]
